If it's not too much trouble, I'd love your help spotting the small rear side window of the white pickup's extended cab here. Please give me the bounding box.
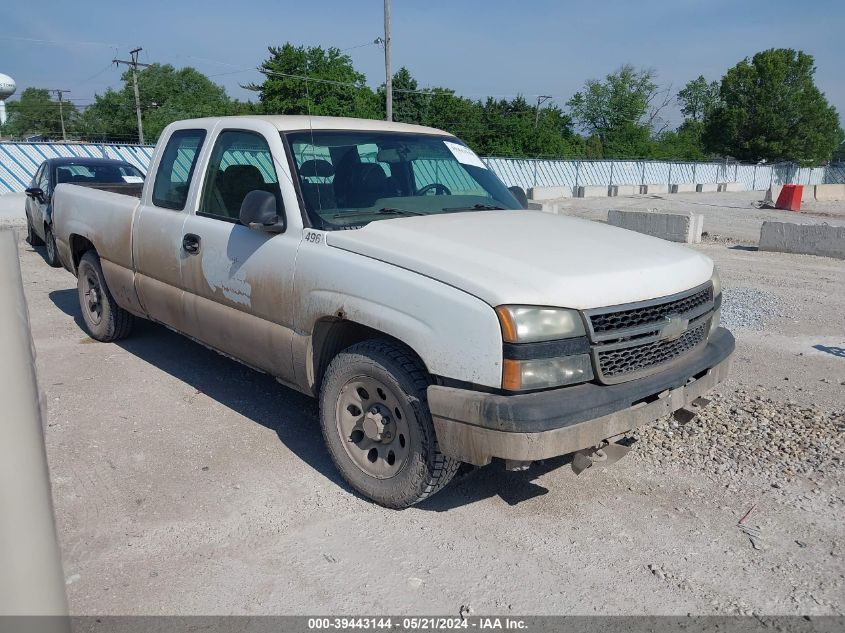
[153,130,205,211]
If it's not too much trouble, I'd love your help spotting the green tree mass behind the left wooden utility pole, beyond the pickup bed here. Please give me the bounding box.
[76,64,234,142]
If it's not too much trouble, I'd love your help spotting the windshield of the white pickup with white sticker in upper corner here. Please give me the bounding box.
[286,130,521,230]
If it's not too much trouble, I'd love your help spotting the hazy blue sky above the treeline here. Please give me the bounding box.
[0,0,845,130]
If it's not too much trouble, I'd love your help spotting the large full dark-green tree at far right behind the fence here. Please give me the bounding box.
[703,48,843,165]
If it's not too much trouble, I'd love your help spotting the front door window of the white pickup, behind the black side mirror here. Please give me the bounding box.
[198,130,282,222]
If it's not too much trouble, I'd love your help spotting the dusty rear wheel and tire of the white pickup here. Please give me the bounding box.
[76,251,135,343]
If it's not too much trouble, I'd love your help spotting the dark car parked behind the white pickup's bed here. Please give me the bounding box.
[26,157,144,267]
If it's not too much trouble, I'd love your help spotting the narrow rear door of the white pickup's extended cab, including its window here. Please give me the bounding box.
[132,129,207,330]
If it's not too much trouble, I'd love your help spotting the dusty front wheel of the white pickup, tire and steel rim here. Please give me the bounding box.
[320,340,460,508]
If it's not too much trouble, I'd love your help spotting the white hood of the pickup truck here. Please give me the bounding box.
[326,211,713,309]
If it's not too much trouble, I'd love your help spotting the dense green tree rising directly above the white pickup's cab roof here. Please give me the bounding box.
[245,43,384,119]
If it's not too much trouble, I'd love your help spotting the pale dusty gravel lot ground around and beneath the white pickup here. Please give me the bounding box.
[0,189,845,615]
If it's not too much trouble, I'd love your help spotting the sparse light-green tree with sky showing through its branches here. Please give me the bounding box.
[567,64,667,158]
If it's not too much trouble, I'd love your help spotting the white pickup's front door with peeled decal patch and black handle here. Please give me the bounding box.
[175,121,301,382]
